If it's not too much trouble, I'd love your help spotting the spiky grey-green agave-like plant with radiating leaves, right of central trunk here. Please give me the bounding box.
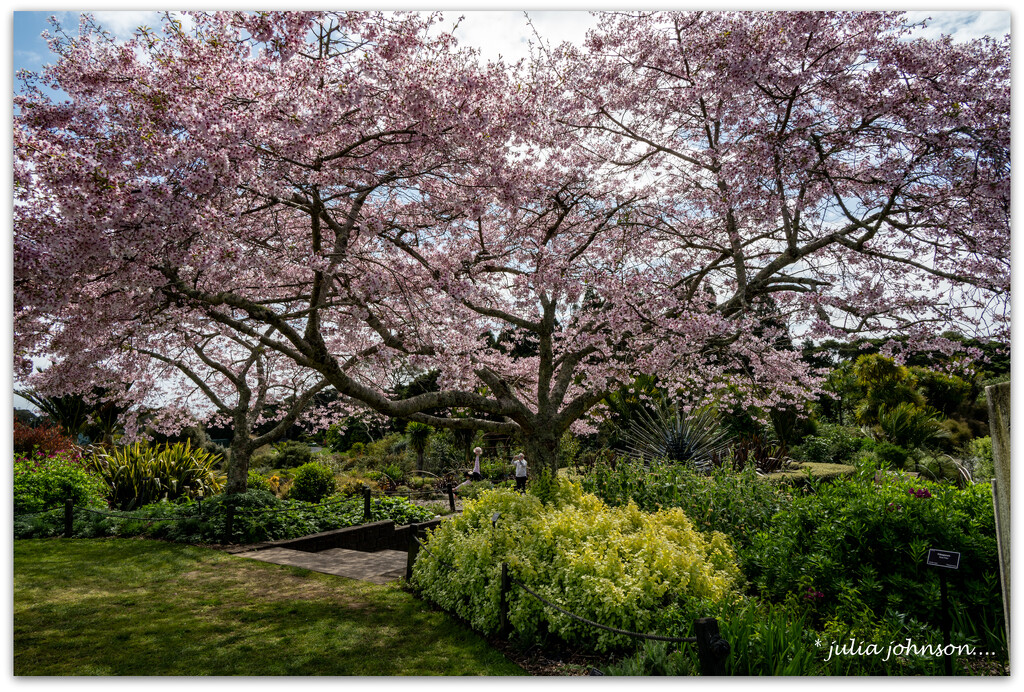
[624,404,729,471]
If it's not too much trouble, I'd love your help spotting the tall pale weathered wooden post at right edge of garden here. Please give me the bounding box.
[985,382,1011,647]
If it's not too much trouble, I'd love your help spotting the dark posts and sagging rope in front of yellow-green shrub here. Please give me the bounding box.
[406,524,730,676]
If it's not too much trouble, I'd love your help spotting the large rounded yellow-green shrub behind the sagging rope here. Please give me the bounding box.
[413,480,739,651]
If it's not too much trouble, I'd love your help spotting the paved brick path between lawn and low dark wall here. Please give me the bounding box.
[238,548,408,583]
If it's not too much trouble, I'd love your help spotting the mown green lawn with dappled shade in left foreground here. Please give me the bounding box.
[14,538,524,676]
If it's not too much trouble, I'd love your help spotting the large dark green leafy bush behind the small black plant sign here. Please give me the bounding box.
[741,475,1002,642]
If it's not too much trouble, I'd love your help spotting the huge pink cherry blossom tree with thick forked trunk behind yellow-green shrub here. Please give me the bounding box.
[14,12,1010,469]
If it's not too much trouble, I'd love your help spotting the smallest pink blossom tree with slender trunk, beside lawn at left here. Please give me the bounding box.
[18,300,350,492]
